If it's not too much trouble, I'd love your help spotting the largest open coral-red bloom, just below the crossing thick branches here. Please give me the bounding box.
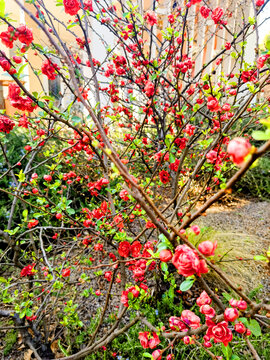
[172,245,208,277]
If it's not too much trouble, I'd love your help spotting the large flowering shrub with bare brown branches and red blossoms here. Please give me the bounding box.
[0,0,270,360]
